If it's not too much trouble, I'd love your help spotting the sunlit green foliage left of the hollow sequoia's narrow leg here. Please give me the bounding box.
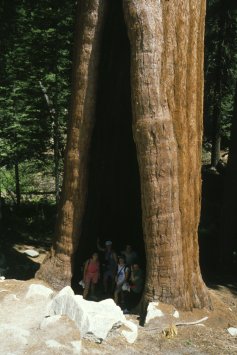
[0,0,76,200]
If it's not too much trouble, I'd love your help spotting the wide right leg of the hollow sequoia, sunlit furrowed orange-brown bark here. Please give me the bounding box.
[124,0,210,309]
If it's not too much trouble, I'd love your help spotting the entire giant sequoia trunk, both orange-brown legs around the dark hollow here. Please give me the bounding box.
[38,0,210,309]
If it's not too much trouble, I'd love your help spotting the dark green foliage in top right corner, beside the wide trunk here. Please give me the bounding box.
[204,0,237,147]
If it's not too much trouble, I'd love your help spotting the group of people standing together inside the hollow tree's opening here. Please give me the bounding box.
[83,240,144,313]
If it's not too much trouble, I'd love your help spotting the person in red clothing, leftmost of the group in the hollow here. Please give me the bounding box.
[83,253,100,298]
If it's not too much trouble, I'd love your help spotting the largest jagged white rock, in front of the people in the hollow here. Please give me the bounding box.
[49,286,126,342]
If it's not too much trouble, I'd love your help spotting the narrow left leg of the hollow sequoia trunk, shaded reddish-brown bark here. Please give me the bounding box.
[36,0,105,289]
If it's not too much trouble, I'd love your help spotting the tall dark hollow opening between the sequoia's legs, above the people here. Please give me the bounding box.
[72,1,145,285]
